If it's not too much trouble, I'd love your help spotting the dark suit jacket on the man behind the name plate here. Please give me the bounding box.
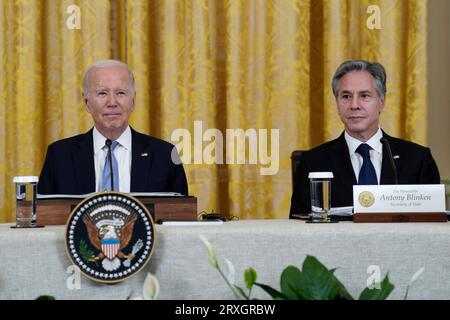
[290,132,440,218]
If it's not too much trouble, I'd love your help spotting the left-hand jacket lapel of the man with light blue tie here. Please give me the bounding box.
[72,129,95,194]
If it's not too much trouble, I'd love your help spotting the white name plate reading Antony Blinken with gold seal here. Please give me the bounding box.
[353,184,445,213]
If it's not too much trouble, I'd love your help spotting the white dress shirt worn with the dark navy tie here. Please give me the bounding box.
[344,128,383,184]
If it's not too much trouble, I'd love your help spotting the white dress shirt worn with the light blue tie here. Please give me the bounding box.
[92,126,131,193]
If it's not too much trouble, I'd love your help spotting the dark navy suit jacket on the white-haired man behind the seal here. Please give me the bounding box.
[38,129,188,195]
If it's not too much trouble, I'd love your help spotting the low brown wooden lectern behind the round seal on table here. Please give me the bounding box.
[36,196,197,226]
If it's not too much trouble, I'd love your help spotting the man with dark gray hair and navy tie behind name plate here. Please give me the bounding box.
[290,60,440,218]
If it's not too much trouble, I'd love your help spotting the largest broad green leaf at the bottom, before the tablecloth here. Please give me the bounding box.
[296,256,353,300]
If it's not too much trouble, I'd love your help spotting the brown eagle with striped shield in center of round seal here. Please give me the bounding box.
[83,215,137,271]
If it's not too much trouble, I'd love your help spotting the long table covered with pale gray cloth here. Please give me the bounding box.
[0,220,450,299]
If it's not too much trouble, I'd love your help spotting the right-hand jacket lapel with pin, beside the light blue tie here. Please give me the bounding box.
[130,128,152,192]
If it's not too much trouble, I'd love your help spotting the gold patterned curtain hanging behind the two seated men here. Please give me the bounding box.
[0,0,427,222]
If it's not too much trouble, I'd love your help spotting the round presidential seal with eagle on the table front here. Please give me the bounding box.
[66,192,155,283]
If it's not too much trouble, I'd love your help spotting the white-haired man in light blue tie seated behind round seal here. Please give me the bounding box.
[38,60,188,195]
